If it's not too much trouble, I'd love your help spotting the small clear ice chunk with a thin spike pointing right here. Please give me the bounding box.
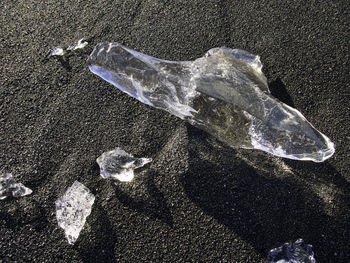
[96,148,152,182]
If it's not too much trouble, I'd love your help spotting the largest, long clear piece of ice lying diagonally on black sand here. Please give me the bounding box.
[88,43,334,162]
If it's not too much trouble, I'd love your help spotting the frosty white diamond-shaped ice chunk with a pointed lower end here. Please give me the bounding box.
[55,181,95,245]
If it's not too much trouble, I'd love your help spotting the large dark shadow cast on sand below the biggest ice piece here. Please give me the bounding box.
[180,125,350,262]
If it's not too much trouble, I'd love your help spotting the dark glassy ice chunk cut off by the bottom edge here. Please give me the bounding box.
[268,239,316,263]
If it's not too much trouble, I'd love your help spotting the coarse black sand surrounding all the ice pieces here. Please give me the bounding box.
[0,0,350,263]
